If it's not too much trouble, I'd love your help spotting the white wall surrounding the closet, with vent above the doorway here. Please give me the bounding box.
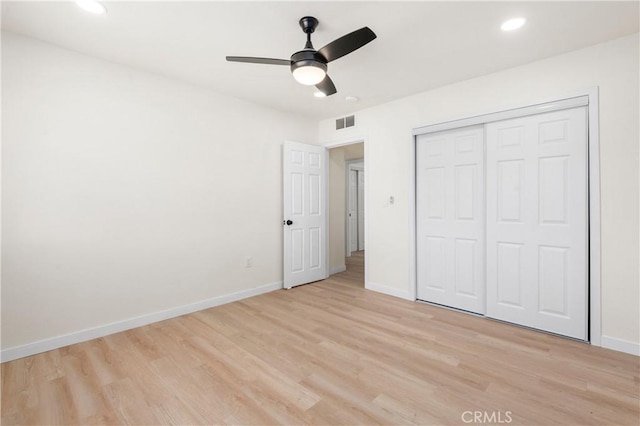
[319,34,640,350]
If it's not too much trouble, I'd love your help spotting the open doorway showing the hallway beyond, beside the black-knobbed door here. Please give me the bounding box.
[329,141,366,288]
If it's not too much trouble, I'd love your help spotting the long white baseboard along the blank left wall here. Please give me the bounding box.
[0,282,282,362]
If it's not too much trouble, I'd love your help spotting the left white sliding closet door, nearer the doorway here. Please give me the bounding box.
[416,126,485,314]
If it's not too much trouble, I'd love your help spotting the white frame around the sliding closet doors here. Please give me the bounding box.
[408,86,602,346]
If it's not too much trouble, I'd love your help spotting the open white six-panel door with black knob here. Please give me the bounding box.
[282,142,327,288]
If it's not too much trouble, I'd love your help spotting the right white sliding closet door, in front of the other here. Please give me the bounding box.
[487,107,588,340]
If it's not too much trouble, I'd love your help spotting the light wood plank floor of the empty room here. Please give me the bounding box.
[2,251,640,425]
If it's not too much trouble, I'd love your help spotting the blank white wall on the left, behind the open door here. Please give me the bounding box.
[2,33,317,350]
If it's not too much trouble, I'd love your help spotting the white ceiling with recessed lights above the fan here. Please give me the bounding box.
[2,1,640,119]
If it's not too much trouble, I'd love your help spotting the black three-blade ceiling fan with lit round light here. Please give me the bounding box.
[227,16,376,96]
